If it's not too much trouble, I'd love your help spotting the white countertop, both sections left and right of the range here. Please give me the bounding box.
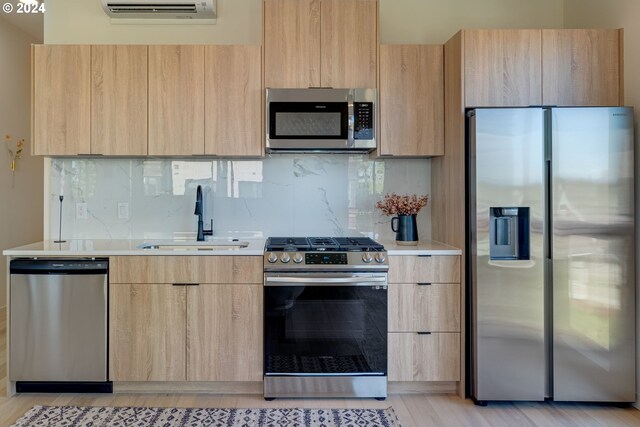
[2,238,462,257]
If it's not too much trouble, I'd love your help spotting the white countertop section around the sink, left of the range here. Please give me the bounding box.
[2,239,265,257]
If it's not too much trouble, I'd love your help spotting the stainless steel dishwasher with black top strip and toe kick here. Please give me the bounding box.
[9,258,112,393]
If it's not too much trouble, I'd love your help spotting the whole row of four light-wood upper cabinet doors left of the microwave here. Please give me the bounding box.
[32,45,263,157]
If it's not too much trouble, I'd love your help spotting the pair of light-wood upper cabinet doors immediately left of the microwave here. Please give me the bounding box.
[149,45,263,157]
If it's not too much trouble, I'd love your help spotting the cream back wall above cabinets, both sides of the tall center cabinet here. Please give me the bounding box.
[45,0,563,44]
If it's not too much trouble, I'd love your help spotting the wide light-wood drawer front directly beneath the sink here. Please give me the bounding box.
[109,256,262,283]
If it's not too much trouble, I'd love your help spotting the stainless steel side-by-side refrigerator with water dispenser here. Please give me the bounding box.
[467,107,636,403]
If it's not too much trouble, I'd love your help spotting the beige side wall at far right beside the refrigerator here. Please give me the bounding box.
[565,0,640,406]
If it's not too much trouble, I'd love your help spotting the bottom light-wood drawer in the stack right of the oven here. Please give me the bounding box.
[388,333,460,381]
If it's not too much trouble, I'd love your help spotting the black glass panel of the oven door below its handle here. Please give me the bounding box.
[265,285,387,375]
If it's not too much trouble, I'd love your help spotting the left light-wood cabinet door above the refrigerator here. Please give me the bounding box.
[464,30,542,107]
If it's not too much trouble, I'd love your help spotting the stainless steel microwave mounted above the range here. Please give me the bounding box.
[265,88,377,153]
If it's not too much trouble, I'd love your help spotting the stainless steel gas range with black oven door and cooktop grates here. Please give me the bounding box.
[264,237,388,399]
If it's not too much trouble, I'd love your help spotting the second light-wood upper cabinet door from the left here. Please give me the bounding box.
[91,45,147,156]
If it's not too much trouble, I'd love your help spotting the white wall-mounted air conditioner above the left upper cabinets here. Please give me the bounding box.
[102,0,217,23]
